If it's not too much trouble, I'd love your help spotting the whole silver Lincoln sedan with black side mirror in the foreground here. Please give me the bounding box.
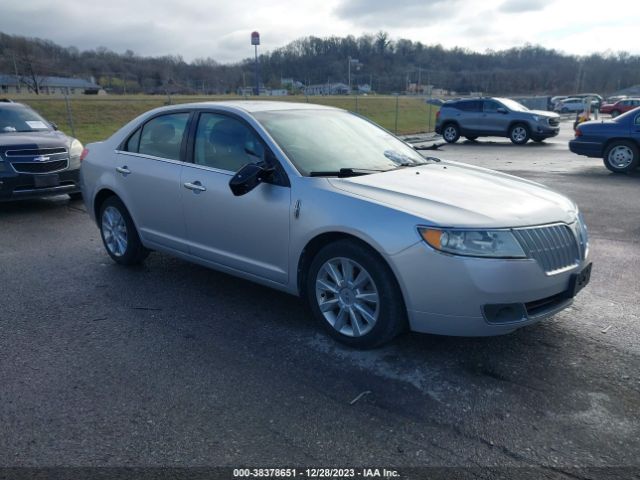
[81,101,591,348]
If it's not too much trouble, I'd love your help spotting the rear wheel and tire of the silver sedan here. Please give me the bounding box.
[98,196,149,265]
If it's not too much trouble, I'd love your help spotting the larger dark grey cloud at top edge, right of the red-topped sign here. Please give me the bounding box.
[334,0,459,30]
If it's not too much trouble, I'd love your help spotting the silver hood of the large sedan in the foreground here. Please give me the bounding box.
[329,162,577,228]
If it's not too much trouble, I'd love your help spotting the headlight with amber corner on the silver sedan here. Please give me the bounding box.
[418,227,527,258]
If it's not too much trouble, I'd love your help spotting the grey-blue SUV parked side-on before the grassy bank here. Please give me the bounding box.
[436,98,560,145]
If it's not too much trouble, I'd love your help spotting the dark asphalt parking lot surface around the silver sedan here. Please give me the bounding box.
[0,119,640,478]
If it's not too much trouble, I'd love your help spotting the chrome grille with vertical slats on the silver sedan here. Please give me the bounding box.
[513,223,584,275]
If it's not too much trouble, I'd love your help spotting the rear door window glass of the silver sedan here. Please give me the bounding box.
[126,112,189,160]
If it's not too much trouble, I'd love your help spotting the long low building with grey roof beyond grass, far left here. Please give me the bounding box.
[0,74,104,95]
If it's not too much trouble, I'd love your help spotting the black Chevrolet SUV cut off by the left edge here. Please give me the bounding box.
[0,100,83,201]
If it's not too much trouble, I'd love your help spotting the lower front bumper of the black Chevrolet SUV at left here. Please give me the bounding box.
[0,168,80,201]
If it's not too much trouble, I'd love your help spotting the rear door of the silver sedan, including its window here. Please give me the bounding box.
[115,111,191,252]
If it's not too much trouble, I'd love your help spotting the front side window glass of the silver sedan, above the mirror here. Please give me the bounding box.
[194,113,267,172]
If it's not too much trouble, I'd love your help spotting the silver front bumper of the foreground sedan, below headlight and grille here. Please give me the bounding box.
[389,242,589,336]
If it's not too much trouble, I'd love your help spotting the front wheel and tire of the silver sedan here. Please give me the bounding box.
[305,240,407,349]
